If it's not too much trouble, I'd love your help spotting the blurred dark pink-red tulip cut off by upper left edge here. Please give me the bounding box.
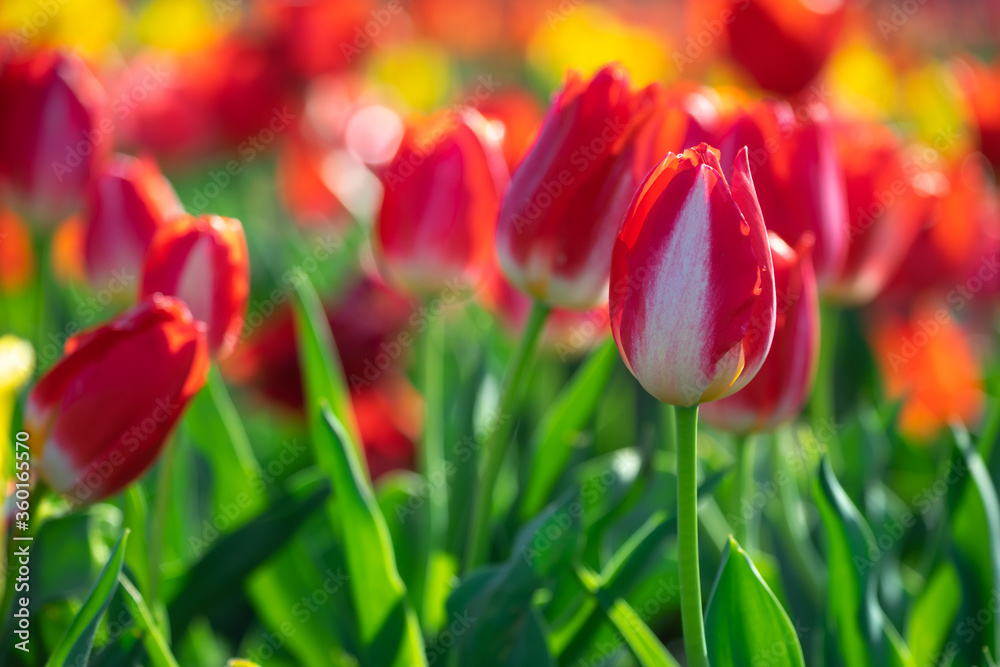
[0,51,114,223]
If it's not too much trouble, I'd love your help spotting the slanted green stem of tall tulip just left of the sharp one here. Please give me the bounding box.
[465,301,550,572]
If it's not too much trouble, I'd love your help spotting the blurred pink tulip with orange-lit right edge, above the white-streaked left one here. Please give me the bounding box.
[84,155,184,287]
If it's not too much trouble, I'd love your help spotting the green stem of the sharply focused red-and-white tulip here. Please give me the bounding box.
[677,404,709,667]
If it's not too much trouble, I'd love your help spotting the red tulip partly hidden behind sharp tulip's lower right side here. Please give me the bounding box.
[701,233,819,433]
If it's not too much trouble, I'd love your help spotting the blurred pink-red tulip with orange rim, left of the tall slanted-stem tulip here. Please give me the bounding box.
[375,110,507,295]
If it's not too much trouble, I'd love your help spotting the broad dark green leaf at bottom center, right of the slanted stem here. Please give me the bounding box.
[448,490,583,667]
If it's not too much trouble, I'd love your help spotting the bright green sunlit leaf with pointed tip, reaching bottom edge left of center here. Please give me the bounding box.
[312,408,426,667]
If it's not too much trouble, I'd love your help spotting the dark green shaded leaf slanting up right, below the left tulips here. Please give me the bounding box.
[168,482,330,639]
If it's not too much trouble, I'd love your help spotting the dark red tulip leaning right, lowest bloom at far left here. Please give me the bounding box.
[25,297,209,503]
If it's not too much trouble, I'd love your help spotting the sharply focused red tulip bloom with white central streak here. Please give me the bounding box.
[610,144,775,407]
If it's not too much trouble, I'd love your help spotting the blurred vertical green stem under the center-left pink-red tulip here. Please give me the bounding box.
[421,310,448,550]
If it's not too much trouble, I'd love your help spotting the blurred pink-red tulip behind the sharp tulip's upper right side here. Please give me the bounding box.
[719,102,848,286]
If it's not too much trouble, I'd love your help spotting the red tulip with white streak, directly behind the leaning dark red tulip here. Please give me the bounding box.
[140,215,250,359]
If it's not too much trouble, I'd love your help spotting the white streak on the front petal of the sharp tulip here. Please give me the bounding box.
[631,169,712,406]
